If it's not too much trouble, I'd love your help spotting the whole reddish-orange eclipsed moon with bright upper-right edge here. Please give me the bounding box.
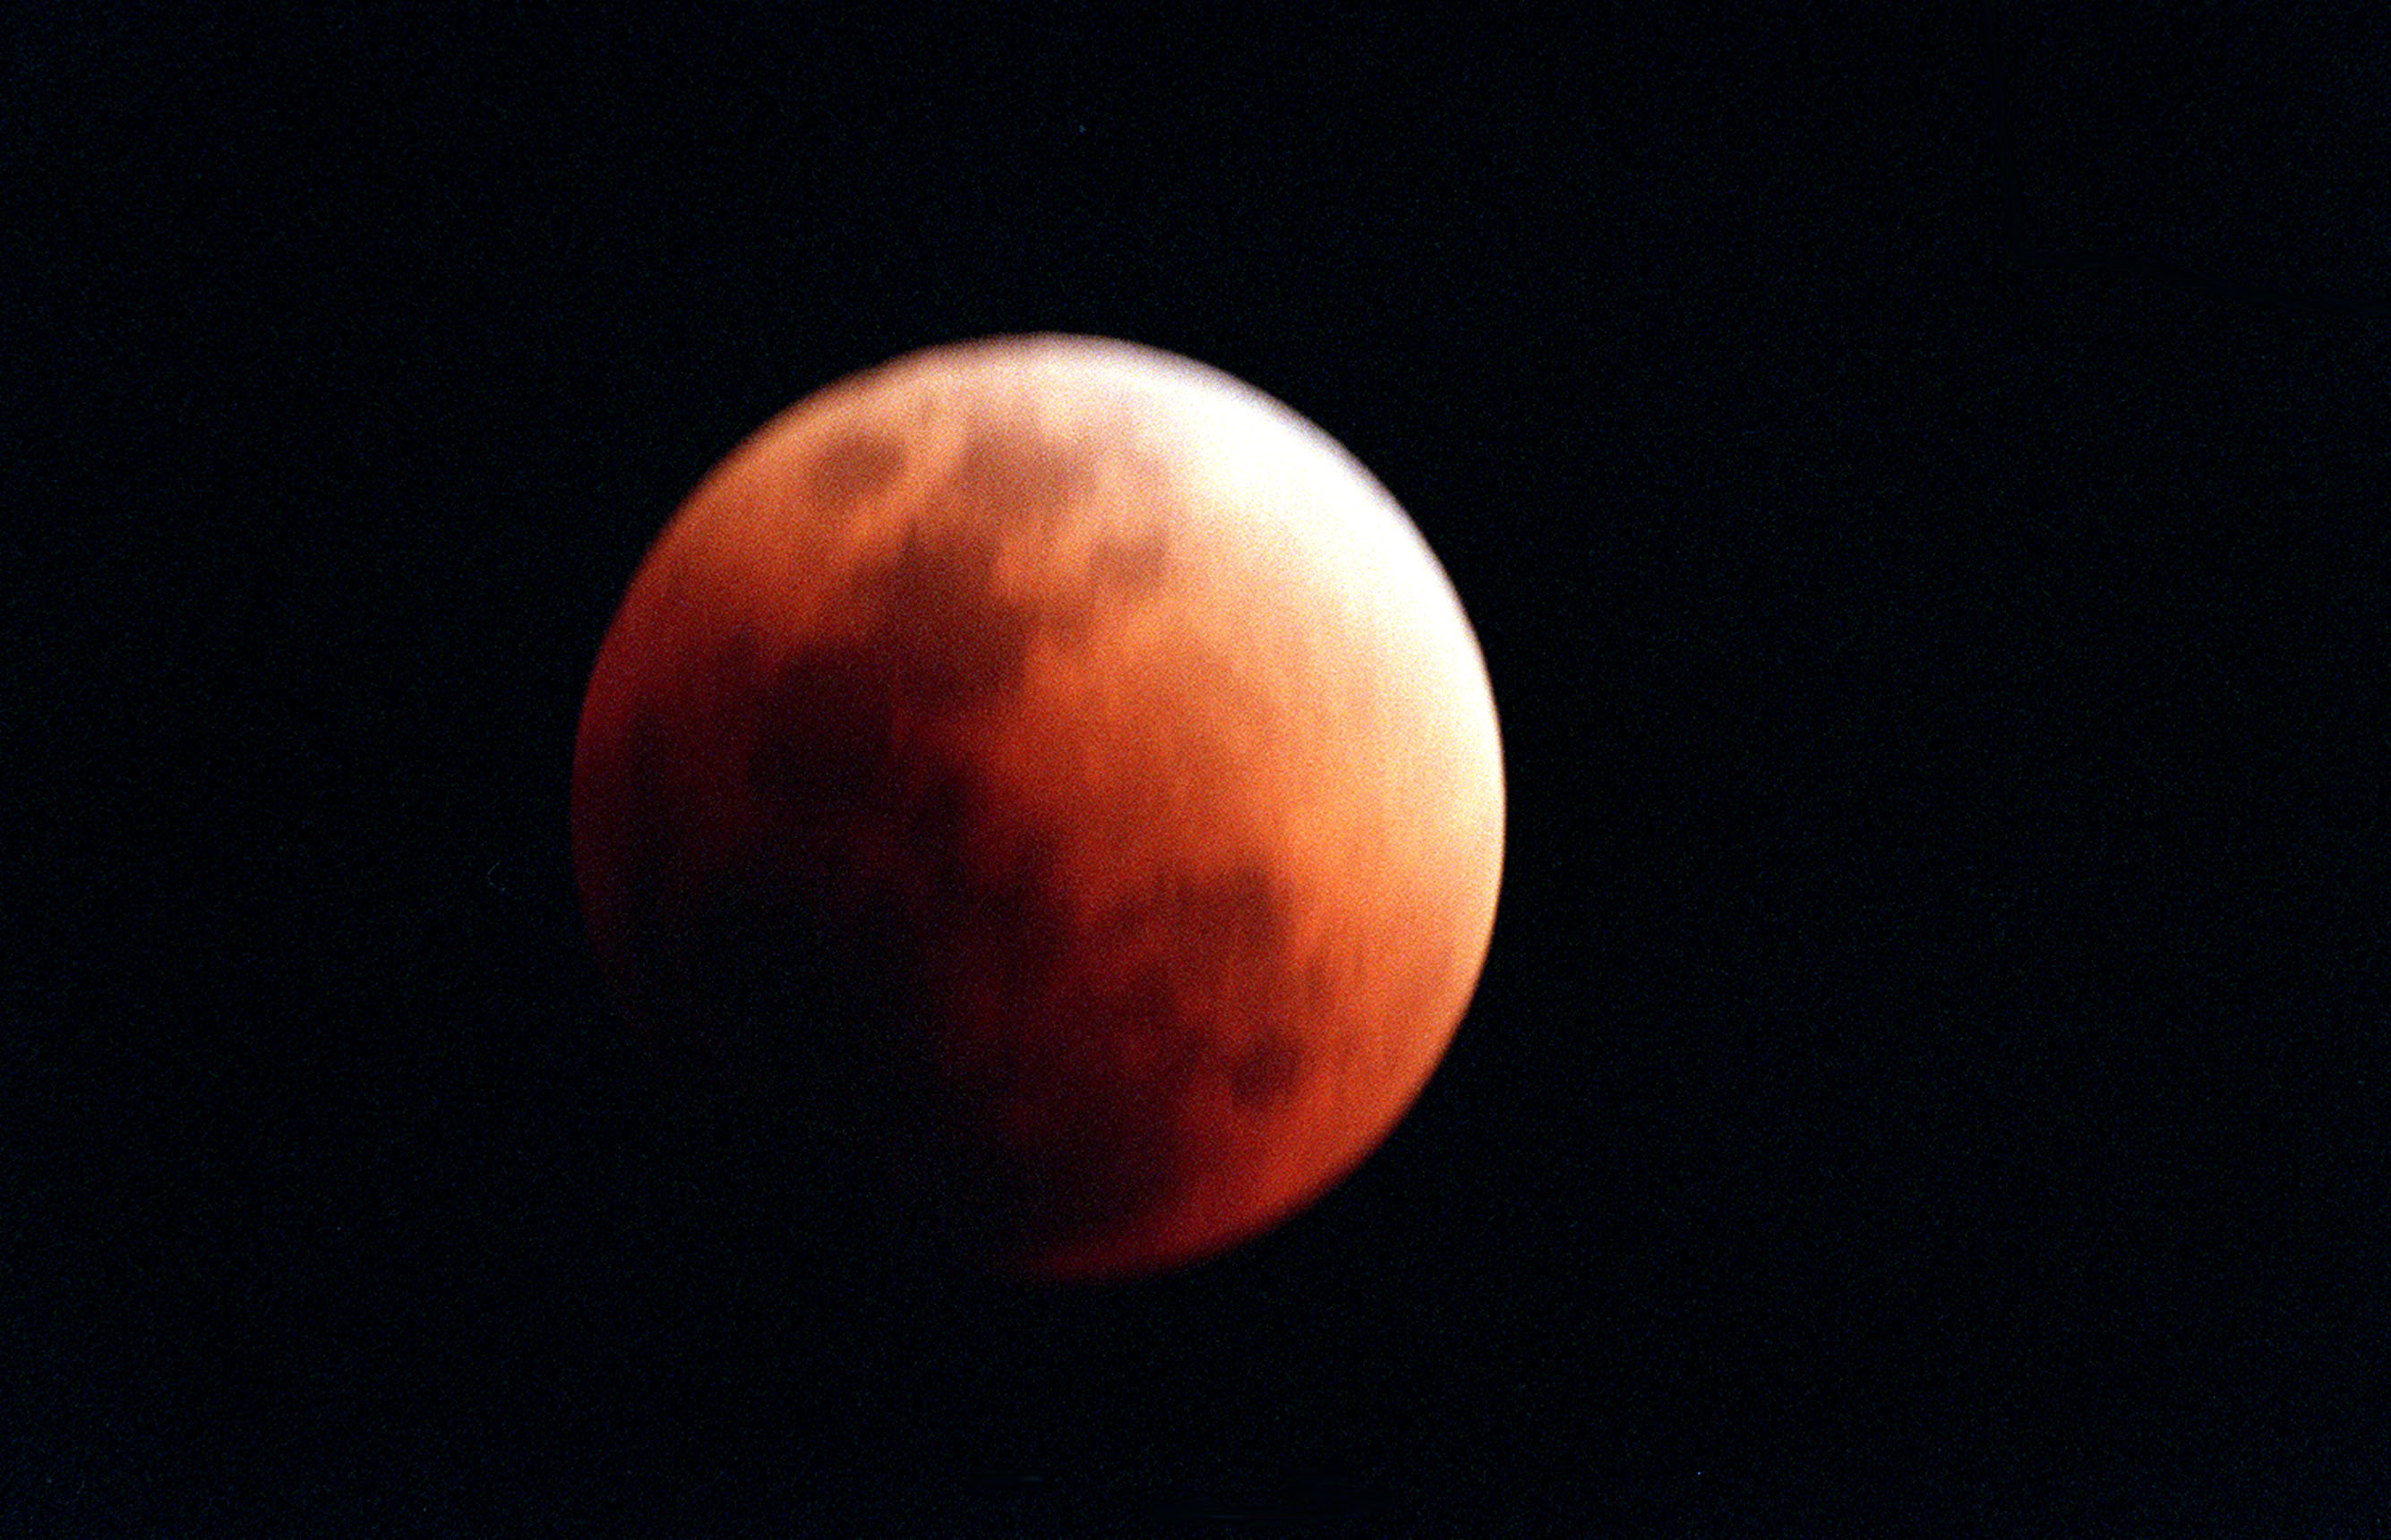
[571,338,1504,1282]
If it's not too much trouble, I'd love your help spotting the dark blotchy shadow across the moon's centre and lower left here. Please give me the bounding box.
[583,415,1327,1270]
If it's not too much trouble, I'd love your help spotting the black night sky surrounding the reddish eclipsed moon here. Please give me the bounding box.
[0,4,2391,1537]
